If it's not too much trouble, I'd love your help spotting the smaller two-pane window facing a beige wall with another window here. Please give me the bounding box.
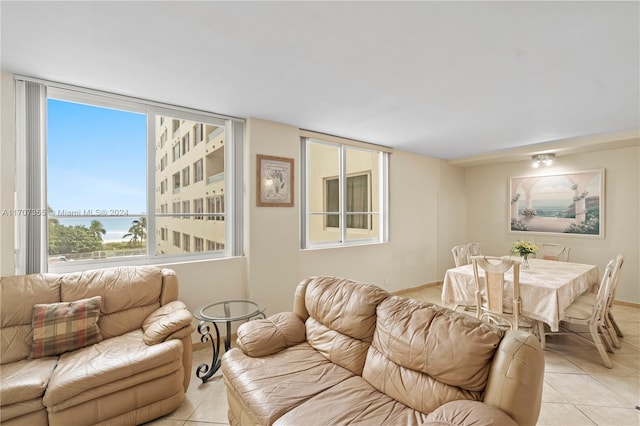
[302,133,388,248]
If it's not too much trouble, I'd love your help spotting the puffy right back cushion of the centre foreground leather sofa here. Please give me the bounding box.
[362,296,503,413]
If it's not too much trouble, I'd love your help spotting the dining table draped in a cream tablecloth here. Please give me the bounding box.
[442,258,598,332]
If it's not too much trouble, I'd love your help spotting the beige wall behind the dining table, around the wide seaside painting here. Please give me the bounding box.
[465,145,640,303]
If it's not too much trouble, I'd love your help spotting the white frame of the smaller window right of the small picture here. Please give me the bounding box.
[300,136,391,250]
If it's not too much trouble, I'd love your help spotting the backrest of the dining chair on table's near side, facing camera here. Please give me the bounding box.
[471,256,522,330]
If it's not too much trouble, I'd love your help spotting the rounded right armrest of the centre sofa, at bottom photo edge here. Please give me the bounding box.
[425,400,518,426]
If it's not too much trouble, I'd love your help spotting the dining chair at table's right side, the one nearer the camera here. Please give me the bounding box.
[549,259,616,368]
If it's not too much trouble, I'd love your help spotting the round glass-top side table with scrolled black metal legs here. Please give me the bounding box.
[193,299,266,383]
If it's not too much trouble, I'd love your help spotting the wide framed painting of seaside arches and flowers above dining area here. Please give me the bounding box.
[509,169,605,238]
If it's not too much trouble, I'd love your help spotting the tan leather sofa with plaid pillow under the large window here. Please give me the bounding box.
[0,266,193,426]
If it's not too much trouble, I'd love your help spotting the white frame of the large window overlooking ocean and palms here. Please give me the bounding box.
[14,75,245,274]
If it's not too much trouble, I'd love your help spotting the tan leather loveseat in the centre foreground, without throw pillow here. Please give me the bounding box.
[222,277,544,426]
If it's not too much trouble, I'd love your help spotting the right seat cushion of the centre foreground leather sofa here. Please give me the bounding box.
[274,376,427,426]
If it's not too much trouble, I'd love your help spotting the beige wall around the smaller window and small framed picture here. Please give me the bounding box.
[245,119,450,313]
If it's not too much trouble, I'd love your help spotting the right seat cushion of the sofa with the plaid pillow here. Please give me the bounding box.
[44,330,183,409]
